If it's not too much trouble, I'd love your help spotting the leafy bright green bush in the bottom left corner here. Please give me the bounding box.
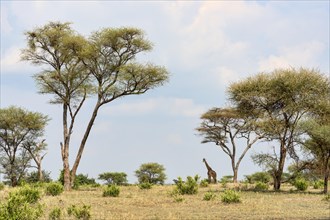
[0,187,43,220]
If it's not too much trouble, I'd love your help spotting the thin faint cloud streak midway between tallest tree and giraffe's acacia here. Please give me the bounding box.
[103,98,205,117]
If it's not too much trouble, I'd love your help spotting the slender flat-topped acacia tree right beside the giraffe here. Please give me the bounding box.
[196,108,262,183]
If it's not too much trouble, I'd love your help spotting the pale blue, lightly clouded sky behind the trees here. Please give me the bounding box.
[0,0,330,183]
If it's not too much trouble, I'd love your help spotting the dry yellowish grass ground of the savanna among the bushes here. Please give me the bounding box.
[0,184,330,220]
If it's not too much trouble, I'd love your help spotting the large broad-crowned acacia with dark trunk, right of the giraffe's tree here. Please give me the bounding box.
[228,68,330,190]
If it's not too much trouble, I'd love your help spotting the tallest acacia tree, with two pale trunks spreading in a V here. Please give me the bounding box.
[22,22,168,190]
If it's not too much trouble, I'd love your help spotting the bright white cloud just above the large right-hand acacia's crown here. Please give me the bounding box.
[259,41,326,72]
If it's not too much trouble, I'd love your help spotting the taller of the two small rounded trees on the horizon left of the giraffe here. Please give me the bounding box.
[135,163,166,184]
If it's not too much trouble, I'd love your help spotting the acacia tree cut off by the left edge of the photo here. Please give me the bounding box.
[0,106,48,186]
